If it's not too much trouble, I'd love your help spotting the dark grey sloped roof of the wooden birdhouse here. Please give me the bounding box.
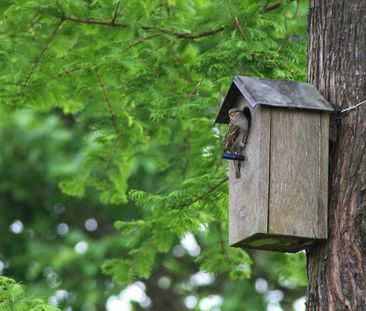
[215,76,334,123]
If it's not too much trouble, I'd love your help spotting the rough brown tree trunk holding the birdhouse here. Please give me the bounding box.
[307,0,366,311]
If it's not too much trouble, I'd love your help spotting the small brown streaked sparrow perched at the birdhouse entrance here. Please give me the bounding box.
[224,108,250,178]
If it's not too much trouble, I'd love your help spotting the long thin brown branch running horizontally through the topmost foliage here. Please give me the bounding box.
[64,16,225,40]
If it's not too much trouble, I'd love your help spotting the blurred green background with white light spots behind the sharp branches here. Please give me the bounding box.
[0,106,306,311]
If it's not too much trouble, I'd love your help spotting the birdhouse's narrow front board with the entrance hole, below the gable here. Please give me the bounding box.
[229,96,269,245]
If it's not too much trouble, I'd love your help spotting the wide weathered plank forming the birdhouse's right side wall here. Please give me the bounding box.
[269,109,321,238]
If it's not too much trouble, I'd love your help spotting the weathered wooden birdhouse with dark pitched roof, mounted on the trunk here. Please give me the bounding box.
[215,76,333,252]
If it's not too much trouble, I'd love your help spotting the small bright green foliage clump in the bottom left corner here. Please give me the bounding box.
[0,276,60,311]
